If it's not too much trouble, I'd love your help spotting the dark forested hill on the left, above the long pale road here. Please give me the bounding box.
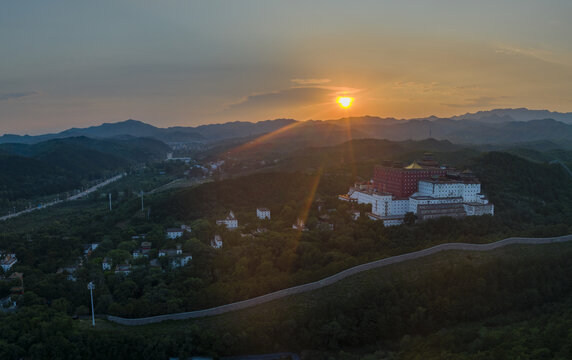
[0,137,169,200]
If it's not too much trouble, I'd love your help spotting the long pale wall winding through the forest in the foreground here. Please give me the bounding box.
[107,235,572,326]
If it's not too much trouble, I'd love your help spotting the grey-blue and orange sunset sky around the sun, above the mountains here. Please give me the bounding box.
[0,0,572,134]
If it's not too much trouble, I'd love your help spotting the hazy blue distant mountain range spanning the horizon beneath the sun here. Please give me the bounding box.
[0,108,572,146]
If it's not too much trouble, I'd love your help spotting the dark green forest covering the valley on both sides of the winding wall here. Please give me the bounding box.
[0,144,572,359]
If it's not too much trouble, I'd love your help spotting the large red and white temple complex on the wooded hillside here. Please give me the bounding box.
[339,154,494,226]
